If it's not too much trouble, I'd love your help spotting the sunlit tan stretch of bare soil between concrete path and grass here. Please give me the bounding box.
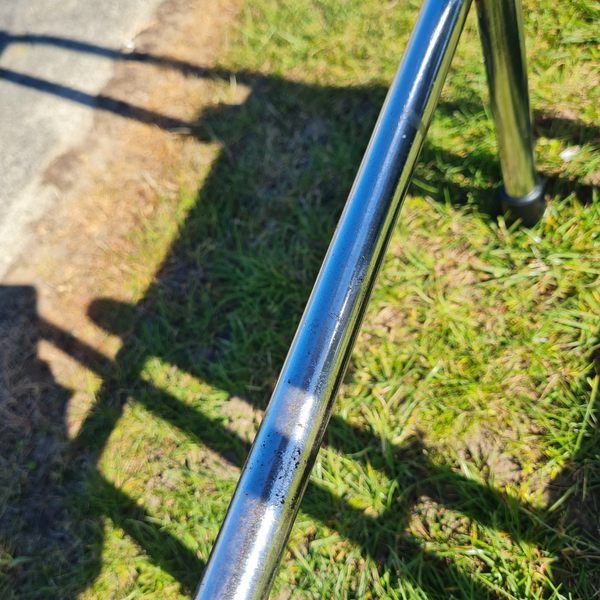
[3,0,237,352]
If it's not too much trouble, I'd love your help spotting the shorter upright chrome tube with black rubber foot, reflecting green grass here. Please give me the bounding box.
[476,0,543,222]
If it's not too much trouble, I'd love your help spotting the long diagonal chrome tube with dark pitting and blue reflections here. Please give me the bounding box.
[195,0,471,600]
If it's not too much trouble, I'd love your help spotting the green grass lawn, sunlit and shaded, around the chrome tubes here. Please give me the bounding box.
[0,0,600,600]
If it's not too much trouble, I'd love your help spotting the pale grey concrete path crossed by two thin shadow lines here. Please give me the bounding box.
[0,0,161,279]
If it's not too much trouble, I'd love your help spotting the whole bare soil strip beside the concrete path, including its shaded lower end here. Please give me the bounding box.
[0,0,243,598]
